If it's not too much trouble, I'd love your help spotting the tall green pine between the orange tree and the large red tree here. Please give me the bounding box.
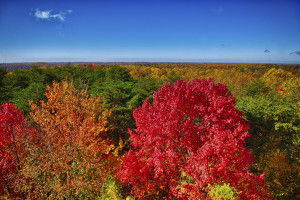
[89,66,162,142]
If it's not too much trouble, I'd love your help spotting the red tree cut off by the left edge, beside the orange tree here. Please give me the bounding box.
[0,103,35,195]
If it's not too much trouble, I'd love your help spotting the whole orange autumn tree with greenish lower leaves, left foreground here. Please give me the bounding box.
[19,82,118,199]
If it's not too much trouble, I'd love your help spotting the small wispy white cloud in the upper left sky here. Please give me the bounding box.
[34,8,72,22]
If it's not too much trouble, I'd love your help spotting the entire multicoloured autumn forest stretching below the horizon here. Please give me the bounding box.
[0,63,300,200]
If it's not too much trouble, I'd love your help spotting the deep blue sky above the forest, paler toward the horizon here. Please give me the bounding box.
[0,0,300,63]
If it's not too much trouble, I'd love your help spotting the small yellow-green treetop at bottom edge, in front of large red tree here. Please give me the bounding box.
[208,183,237,200]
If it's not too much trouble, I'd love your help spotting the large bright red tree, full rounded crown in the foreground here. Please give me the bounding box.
[118,79,269,199]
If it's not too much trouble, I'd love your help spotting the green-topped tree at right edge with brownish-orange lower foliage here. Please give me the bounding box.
[237,93,300,200]
